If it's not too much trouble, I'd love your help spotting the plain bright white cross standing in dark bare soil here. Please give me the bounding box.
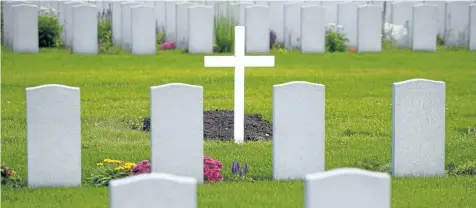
[205,26,274,144]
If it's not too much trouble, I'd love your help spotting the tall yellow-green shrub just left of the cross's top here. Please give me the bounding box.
[213,17,235,53]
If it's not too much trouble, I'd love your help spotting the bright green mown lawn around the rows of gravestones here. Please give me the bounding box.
[1,50,476,208]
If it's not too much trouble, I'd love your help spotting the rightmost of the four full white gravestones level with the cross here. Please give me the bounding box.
[392,79,446,177]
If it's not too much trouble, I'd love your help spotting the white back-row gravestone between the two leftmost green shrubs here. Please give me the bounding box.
[72,4,98,55]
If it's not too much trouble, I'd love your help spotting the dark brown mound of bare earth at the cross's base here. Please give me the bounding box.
[142,110,273,141]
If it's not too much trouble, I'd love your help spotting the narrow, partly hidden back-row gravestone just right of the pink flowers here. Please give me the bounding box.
[175,2,194,49]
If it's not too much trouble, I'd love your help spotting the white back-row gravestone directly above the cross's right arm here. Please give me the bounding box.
[245,5,270,53]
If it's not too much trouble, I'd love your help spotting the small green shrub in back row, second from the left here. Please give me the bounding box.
[98,19,120,54]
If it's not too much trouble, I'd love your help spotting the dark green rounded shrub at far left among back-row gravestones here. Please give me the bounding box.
[38,16,63,48]
